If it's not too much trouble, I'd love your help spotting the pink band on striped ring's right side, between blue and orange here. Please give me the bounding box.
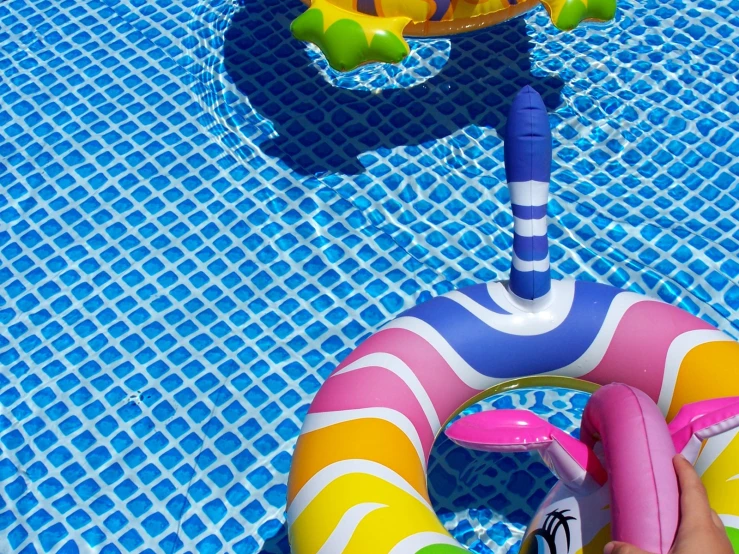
[582,302,713,401]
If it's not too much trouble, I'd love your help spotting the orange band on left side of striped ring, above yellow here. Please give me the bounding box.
[287,418,428,504]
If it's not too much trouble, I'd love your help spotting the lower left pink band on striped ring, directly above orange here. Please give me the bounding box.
[310,367,436,457]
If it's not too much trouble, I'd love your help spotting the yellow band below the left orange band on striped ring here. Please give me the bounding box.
[290,473,446,554]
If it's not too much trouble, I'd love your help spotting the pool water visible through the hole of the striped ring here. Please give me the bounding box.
[428,388,590,554]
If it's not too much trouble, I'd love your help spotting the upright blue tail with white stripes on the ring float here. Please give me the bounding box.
[505,86,552,311]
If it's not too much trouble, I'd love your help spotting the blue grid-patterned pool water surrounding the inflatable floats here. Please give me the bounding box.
[0,0,739,554]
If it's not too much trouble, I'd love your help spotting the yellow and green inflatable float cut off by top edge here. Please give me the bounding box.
[291,0,616,71]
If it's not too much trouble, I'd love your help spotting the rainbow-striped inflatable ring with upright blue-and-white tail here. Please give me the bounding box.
[287,87,739,554]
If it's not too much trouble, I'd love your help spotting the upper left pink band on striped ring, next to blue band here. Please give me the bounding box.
[330,328,480,423]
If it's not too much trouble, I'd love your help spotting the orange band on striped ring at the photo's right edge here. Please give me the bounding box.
[667,341,739,421]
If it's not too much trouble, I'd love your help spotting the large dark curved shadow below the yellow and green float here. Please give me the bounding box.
[223,0,563,175]
